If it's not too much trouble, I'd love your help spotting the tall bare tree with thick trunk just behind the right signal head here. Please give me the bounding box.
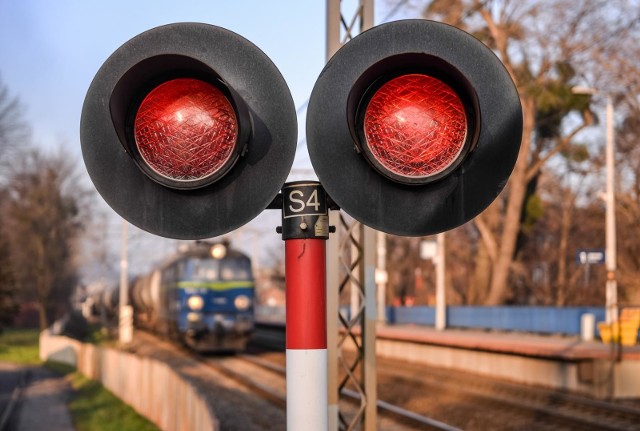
[424,0,639,304]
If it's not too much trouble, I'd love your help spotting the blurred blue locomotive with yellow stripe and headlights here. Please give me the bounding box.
[131,242,255,352]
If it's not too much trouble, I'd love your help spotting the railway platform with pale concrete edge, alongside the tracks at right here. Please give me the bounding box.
[376,325,640,398]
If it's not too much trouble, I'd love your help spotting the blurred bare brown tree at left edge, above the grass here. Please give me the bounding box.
[3,151,87,329]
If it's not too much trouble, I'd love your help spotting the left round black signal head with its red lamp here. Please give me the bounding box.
[80,23,297,239]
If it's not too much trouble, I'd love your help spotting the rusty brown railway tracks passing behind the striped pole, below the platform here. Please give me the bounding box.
[131,330,640,430]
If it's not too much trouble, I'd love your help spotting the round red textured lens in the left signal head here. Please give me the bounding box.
[134,78,238,182]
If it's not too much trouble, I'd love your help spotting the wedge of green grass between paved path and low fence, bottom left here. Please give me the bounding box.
[47,362,158,431]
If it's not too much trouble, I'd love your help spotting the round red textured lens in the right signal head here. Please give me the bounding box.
[363,74,468,184]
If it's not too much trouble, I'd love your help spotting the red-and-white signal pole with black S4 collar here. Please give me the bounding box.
[282,182,329,431]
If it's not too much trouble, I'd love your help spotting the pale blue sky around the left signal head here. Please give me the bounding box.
[0,0,411,280]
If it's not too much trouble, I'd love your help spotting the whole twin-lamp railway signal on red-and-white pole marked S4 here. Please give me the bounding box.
[81,20,522,429]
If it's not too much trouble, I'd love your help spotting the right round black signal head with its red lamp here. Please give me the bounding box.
[307,20,522,236]
